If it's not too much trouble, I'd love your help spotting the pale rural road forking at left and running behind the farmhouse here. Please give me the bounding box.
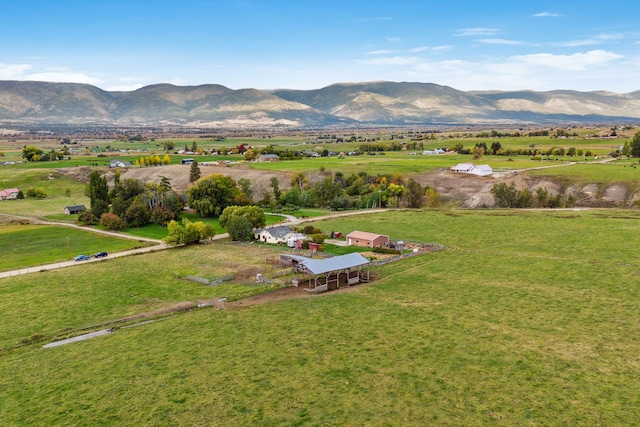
[0,209,388,279]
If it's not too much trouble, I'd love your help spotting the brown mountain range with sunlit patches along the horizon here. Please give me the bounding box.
[0,81,640,128]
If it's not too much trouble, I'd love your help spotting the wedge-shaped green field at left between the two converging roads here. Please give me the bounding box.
[0,225,147,271]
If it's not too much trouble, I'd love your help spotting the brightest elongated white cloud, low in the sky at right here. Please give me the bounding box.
[512,50,623,71]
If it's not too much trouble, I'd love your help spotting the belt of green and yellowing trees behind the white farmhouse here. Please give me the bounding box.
[78,169,440,244]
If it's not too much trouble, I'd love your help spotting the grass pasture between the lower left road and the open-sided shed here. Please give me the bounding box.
[0,243,282,349]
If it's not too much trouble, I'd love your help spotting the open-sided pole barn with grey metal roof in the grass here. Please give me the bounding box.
[280,252,370,292]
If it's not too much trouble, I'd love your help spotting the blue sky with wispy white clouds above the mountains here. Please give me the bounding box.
[0,0,640,92]
